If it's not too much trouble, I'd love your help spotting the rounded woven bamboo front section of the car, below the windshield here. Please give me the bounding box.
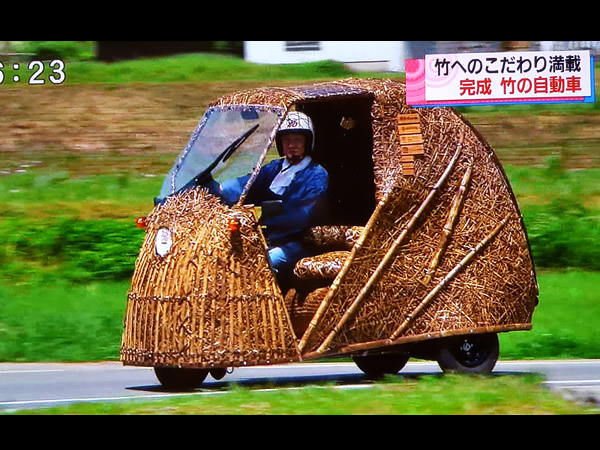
[121,188,299,368]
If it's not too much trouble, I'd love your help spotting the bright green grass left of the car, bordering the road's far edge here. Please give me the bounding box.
[0,277,128,361]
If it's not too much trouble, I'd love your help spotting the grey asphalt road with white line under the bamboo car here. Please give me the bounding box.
[0,360,600,410]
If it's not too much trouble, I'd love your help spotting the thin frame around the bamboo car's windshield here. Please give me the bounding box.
[159,104,287,203]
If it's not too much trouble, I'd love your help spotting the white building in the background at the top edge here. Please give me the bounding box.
[244,41,406,72]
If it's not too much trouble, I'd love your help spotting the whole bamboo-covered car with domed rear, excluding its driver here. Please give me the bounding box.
[120,79,538,387]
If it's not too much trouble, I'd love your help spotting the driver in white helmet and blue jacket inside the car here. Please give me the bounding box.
[211,111,329,293]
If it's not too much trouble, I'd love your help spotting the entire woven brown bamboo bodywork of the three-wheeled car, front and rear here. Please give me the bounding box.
[121,79,538,367]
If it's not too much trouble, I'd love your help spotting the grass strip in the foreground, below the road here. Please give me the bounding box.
[5,375,598,415]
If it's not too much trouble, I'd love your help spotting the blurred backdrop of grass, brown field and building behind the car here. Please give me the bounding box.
[0,41,600,361]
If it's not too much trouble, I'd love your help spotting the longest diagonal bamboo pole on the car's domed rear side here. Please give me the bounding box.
[316,132,464,353]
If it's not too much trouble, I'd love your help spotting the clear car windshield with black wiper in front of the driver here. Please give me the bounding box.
[158,105,284,199]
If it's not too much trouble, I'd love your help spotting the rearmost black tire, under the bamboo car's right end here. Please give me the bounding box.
[437,333,500,374]
